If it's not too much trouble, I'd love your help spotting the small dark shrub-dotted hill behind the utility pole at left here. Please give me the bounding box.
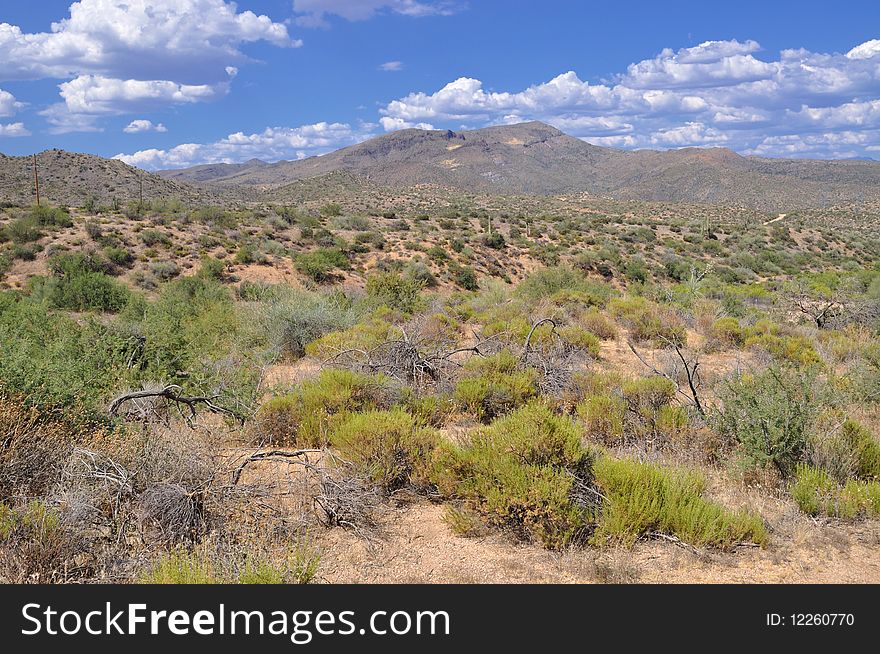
[0,150,217,206]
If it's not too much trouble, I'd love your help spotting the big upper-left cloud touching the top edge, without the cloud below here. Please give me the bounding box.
[0,0,299,84]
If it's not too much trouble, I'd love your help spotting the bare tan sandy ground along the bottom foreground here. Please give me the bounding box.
[319,502,880,583]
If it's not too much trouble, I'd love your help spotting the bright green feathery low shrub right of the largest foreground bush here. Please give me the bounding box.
[593,457,767,548]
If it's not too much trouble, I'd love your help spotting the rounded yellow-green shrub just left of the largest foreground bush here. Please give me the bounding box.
[330,409,438,492]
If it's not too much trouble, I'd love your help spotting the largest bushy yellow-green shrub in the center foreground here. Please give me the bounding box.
[432,403,594,549]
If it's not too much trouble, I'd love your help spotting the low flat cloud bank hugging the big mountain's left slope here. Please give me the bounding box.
[114,122,375,170]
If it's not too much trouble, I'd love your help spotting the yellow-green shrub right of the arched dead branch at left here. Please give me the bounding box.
[256,369,394,447]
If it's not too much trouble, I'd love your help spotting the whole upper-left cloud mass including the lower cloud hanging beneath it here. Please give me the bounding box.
[0,0,301,132]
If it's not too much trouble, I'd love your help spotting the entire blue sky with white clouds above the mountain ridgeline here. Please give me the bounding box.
[0,0,880,169]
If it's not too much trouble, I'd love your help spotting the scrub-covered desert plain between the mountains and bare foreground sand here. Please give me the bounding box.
[0,197,880,583]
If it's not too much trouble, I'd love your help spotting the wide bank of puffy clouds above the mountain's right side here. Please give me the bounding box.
[380,40,880,157]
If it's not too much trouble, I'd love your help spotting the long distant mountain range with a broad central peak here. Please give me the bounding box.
[159,122,880,210]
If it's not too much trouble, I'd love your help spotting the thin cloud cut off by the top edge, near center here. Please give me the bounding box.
[293,0,462,27]
